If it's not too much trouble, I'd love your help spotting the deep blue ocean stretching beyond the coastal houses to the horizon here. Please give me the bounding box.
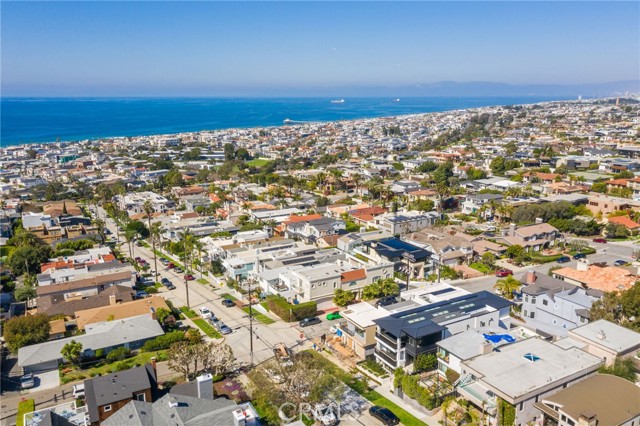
[0,96,566,146]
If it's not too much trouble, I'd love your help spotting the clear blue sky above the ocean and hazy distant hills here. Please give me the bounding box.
[0,1,640,96]
